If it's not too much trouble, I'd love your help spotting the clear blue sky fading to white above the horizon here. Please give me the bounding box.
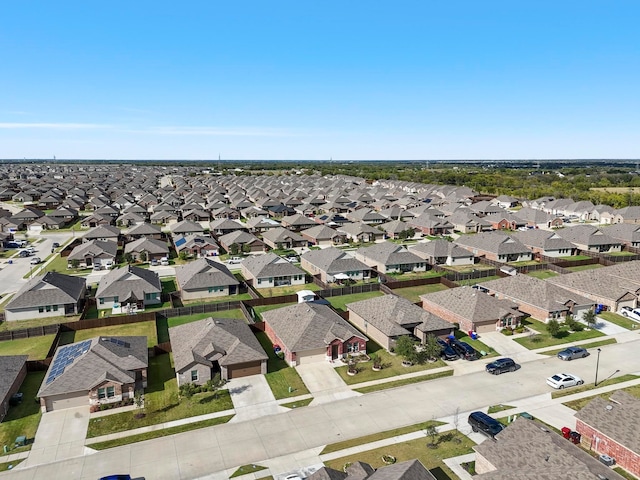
[0,0,640,160]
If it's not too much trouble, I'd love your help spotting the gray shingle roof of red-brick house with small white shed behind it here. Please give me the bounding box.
[262,303,368,352]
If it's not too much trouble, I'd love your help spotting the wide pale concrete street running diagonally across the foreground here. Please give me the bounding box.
[0,334,640,480]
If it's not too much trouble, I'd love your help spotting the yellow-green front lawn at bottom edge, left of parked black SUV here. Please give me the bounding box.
[325,432,475,479]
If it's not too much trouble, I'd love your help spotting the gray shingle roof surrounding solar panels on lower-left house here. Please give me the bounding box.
[38,337,148,397]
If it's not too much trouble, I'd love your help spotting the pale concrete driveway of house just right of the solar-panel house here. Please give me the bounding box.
[227,375,288,422]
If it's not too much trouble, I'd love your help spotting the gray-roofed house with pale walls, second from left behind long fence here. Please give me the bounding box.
[96,265,162,311]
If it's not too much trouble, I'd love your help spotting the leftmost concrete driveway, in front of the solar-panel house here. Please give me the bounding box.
[24,405,89,467]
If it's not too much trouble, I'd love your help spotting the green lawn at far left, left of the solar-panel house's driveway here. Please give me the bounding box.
[0,372,46,453]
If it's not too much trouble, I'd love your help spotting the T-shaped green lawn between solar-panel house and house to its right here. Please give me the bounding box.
[87,354,233,438]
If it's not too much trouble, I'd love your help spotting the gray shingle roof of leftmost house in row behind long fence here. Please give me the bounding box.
[5,272,86,310]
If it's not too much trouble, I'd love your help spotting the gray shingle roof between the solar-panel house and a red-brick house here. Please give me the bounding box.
[169,317,268,371]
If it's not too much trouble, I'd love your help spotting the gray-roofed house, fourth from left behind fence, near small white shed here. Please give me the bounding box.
[242,252,306,288]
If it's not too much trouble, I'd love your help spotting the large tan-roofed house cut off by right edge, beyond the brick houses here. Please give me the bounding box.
[545,261,640,312]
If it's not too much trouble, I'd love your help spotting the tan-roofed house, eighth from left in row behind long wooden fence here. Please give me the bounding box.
[453,231,533,263]
